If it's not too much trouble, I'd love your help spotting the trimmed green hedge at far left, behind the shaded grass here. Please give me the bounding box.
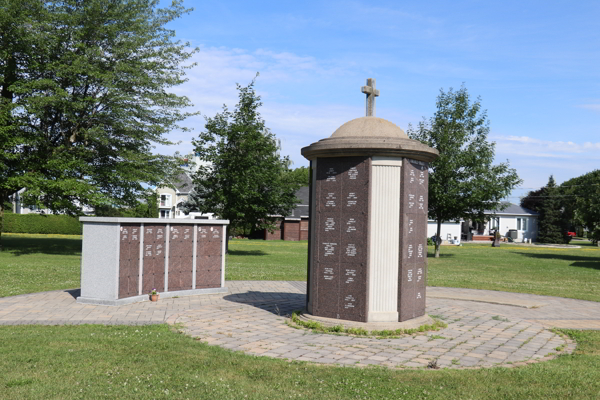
[2,213,82,235]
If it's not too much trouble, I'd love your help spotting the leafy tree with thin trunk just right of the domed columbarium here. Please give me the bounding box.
[407,86,521,257]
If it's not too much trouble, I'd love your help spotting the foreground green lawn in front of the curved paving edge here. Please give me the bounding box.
[0,325,600,400]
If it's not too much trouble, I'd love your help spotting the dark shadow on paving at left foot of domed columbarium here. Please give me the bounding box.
[223,291,306,316]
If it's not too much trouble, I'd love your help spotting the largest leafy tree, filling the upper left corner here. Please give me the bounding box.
[0,0,194,250]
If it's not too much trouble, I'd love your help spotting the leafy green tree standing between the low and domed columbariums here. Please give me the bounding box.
[187,80,298,245]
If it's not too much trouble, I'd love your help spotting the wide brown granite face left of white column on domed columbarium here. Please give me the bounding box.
[309,157,369,321]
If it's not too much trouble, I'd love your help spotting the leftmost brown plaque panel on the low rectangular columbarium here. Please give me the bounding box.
[119,224,141,299]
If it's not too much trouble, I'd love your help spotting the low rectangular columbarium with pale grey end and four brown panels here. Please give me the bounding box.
[77,217,229,305]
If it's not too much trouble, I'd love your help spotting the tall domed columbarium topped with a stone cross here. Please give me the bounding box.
[302,79,438,323]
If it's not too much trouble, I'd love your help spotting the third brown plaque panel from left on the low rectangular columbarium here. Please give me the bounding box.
[169,224,194,291]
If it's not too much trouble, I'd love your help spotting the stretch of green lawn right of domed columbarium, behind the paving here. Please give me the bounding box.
[427,242,600,301]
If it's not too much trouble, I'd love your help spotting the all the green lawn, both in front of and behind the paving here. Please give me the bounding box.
[0,234,600,400]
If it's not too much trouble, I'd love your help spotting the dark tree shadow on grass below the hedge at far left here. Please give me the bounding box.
[2,235,81,256]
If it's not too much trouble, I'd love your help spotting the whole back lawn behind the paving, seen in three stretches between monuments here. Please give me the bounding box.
[0,233,600,301]
